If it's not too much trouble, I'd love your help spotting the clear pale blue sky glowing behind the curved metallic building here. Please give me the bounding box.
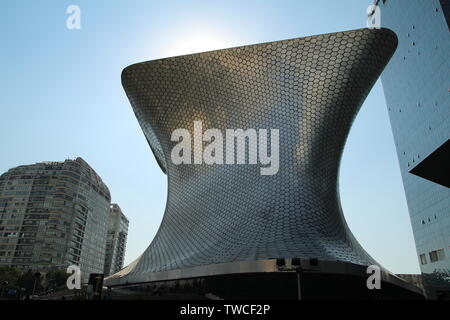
[0,0,419,273]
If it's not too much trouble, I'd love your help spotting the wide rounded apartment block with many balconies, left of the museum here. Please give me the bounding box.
[0,158,111,281]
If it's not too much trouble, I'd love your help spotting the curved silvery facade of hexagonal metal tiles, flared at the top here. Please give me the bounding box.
[110,29,397,283]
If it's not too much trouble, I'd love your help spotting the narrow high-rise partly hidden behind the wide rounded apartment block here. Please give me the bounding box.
[104,203,129,276]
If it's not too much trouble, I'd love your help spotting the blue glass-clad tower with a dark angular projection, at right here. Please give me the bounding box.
[376,0,450,297]
